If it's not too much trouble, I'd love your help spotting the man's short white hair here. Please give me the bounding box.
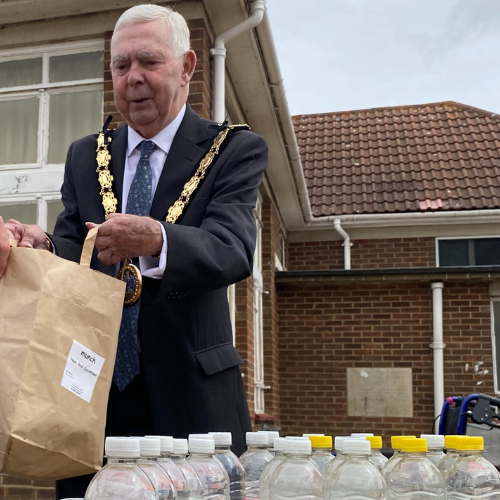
[111,4,190,57]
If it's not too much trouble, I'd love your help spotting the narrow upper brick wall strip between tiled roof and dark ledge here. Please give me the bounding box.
[287,238,436,271]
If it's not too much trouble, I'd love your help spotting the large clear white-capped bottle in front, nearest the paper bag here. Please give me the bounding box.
[85,437,157,500]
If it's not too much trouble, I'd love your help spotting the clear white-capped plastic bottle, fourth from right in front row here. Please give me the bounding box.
[269,439,323,500]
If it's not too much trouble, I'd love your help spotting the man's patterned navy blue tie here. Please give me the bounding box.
[113,141,156,392]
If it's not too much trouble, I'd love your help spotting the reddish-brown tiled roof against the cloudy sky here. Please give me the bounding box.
[293,102,500,217]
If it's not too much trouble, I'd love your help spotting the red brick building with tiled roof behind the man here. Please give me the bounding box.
[0,0,500,500]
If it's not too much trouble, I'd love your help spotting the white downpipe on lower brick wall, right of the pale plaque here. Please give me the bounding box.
[431,282,446,429]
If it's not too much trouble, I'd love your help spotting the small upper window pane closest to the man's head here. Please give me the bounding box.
[49,52,104,82]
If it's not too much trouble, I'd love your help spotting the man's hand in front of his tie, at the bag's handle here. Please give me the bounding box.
[87,214,163,266]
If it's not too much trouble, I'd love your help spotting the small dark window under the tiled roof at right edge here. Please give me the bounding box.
[437,237,500,267]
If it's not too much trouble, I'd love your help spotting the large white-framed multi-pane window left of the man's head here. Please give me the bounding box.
[0,41,104,170]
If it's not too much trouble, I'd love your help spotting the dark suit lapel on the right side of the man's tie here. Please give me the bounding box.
[148,105,211,220]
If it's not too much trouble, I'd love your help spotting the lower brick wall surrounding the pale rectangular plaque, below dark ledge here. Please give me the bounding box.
[278,283,493,446]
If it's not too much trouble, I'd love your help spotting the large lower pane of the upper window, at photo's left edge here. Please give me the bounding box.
[0,97,39,165]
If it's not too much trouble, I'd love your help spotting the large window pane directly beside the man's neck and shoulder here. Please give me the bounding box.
[48,90,102,163]
